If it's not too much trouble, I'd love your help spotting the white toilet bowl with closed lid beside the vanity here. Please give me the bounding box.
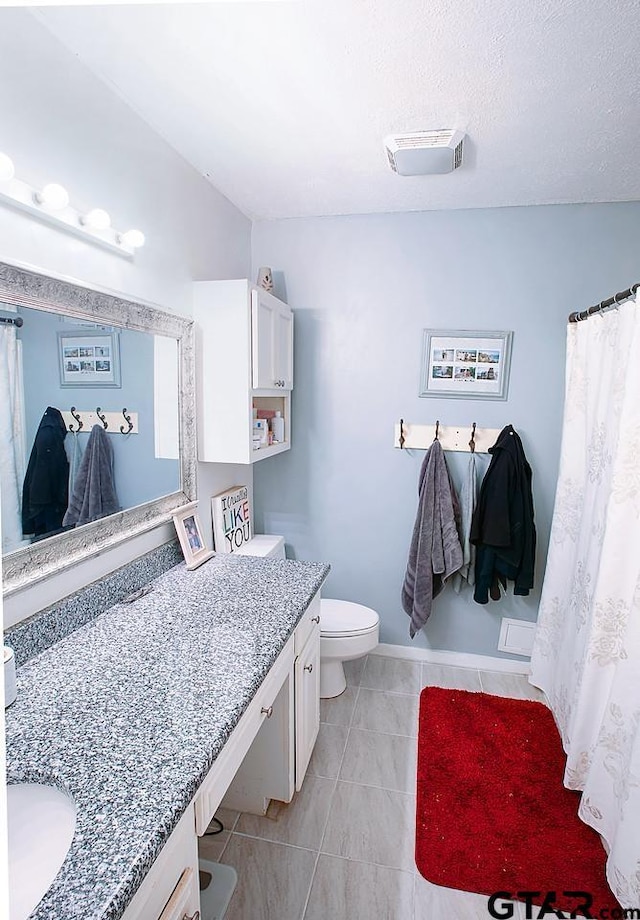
[320,597,380,700]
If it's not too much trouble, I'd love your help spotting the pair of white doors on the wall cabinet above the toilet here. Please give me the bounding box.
[251,290,293,390]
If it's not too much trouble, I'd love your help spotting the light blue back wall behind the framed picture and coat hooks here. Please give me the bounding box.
[252,203,640,657]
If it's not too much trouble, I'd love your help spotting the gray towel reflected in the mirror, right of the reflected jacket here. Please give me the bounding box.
[62,425,120,527]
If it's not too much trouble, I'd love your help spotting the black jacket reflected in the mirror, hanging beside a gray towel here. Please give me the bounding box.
[22,406,69,537]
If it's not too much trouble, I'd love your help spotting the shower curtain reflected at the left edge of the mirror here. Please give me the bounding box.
[0,304,25,554]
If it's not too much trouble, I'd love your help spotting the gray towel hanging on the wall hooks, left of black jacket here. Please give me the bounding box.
[402,441,462,639]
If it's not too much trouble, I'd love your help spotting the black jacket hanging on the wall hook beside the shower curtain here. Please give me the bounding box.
[471,425,536,604]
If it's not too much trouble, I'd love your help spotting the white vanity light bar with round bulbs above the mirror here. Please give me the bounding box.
[0,152,144,259]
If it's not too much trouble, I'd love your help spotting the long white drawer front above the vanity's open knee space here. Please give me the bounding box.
[196,638,293,836]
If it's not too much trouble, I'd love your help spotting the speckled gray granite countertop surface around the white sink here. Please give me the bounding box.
[6,555,329,920]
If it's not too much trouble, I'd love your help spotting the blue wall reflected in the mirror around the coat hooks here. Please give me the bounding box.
[19,309,180,508]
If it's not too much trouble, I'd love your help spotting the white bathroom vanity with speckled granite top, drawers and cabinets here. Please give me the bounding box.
[6,555,329,920]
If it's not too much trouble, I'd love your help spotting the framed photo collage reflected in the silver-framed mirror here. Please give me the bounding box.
[58,329,121,387]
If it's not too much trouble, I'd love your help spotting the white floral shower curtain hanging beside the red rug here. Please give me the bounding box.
[530,301,640,908]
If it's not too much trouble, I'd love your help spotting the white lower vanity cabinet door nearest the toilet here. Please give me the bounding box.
[295,624,320,790]
